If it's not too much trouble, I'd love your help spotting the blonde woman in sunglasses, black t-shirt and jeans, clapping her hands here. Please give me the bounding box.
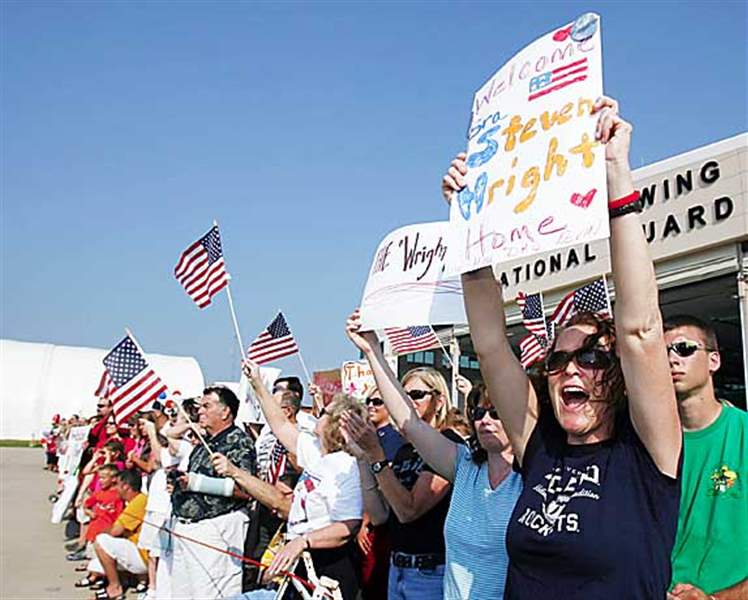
[343,358,462,600]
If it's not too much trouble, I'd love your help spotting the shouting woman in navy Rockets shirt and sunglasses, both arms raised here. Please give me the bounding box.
[442,98,681,599]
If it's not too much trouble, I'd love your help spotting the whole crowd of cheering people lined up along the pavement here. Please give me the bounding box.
[42,98,748,600]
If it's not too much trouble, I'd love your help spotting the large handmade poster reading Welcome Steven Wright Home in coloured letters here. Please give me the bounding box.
[449,13,608,273]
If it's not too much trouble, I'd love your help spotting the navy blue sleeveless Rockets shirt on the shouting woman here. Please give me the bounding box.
[504,409,680,600]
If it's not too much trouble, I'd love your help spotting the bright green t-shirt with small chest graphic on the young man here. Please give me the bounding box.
[673,406,748,594]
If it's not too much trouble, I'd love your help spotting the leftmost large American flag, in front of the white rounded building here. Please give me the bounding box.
[103,334,166,423]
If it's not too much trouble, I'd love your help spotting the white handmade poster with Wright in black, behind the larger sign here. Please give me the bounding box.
[361,221,467,330]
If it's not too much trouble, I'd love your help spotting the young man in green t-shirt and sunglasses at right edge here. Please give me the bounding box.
[665,316,748,600]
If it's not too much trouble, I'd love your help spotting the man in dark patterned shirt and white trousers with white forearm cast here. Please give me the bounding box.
[172,386,255,599]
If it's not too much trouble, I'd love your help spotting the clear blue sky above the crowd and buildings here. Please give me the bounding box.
[0,0,748,380]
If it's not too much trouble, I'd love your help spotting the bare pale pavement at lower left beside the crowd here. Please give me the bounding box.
[0,448,83,600]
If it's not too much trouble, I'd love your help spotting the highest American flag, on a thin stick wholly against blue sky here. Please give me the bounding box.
[174,225,229,308]
